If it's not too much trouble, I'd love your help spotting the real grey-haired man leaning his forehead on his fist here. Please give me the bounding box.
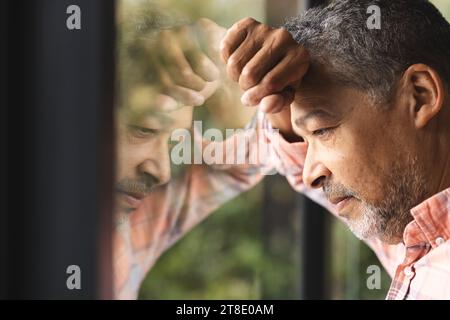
[222,0,450,299]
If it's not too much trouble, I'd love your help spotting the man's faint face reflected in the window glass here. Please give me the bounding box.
[115,107,192,212]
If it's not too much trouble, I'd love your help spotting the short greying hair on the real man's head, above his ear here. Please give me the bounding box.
[284,0,450,103]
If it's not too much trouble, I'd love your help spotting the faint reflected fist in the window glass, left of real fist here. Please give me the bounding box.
[150,19,225,107]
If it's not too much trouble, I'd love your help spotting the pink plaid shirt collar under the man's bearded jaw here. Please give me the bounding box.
[403,188,450,248]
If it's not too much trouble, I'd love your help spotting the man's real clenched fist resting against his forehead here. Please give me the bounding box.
[221,18,309,113]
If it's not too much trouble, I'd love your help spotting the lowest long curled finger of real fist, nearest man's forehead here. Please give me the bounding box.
[241,50,309,106]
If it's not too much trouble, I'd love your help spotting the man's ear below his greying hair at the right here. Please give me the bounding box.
[403,64,445,128]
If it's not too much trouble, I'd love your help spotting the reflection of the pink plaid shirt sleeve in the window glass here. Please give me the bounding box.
[113,116,275,299]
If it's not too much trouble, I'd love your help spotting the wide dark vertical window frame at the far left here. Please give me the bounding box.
[6,0,115,299]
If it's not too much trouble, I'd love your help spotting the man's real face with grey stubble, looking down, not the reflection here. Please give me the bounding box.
[291,66,429,243]
